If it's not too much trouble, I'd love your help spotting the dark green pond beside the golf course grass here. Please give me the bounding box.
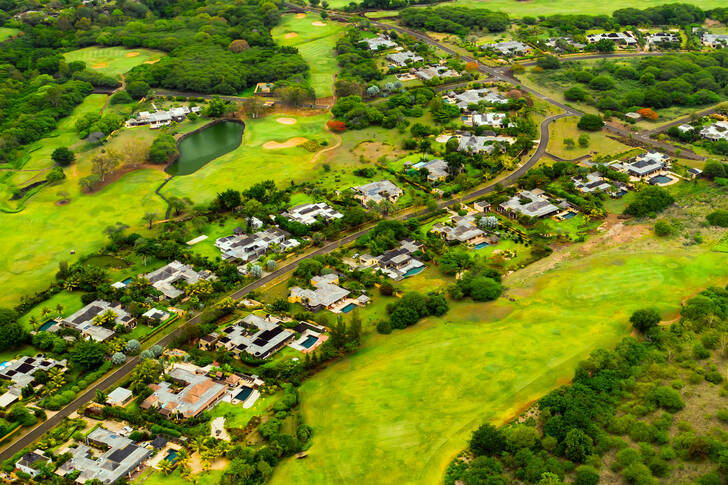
[167,121,243,175]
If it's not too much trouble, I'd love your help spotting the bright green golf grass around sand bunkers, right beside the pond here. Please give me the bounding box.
[164,114,334,203]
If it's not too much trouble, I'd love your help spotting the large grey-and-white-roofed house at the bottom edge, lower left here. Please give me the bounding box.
[56,428,152,484]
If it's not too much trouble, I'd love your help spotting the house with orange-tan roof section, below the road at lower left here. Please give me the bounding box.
[140,365,227,418]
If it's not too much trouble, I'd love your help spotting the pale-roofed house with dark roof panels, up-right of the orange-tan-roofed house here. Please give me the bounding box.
[209,313,295,359]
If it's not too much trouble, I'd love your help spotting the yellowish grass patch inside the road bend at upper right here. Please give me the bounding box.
[547,116,629,160]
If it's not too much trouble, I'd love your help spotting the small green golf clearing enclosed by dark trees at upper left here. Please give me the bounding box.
[63,46,166,78]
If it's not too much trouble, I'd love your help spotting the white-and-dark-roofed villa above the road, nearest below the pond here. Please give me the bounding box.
[215,227,301,263]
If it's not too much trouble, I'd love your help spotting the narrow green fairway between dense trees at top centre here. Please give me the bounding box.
[271,14,346,98]
